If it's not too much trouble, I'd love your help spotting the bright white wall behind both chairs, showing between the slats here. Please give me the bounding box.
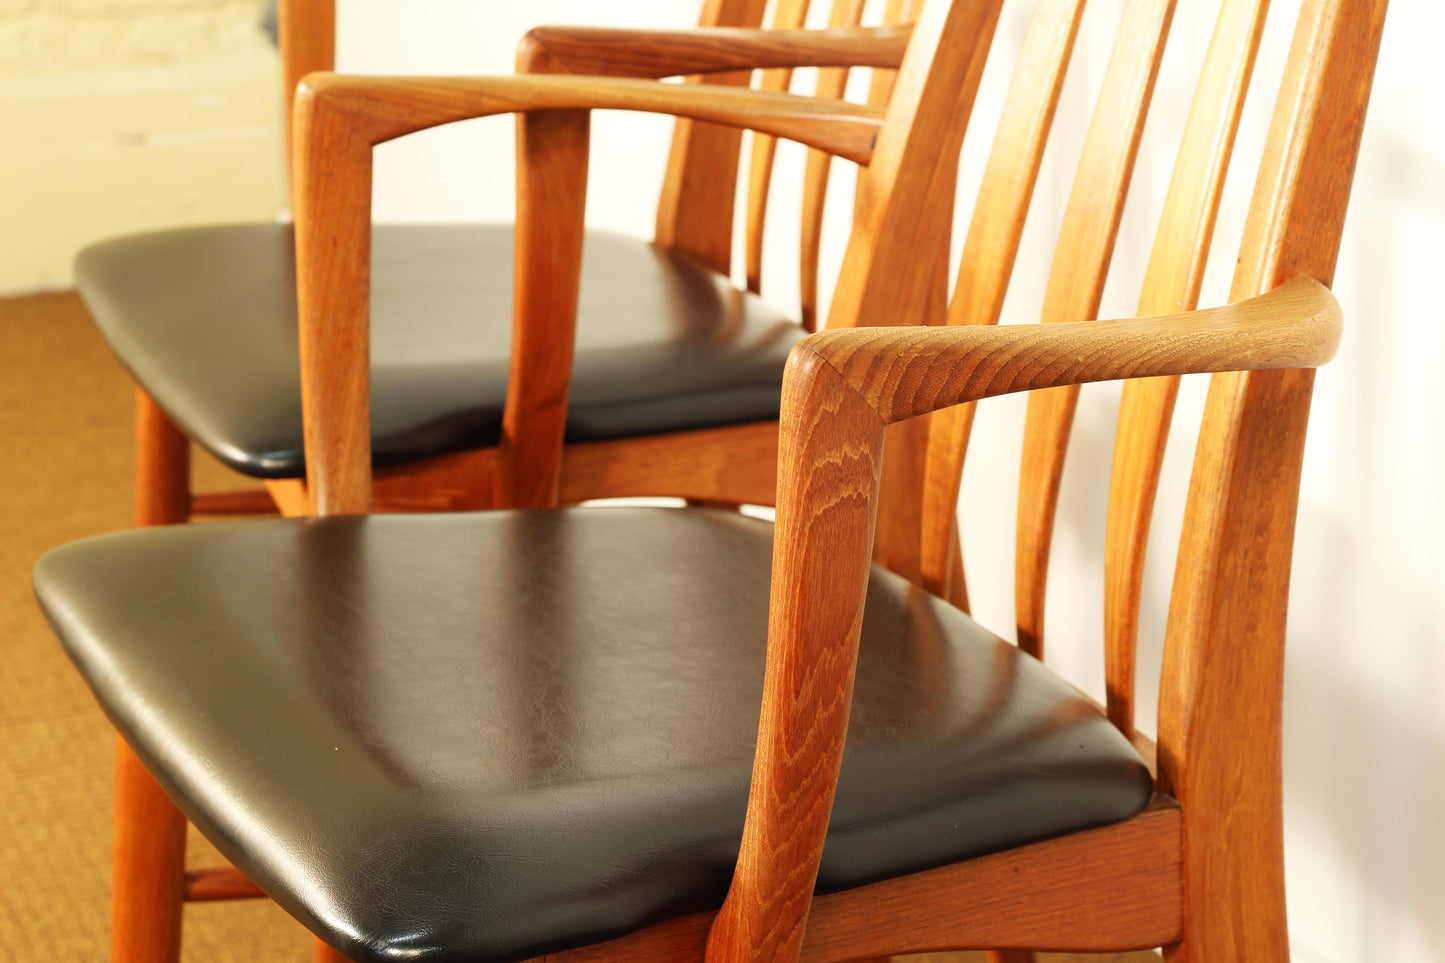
[341,0,1445,963]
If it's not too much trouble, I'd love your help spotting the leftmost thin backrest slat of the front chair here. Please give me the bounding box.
[920,0,1084,600]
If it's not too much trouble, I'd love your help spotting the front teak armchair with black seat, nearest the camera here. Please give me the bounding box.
[36,0,1386,963]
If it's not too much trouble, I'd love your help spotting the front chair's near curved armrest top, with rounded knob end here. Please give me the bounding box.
[796,275,1341,422]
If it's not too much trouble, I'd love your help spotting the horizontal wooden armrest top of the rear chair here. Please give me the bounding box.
[517,26,913,78]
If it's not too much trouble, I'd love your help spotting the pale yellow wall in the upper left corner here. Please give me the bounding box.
[0,0,285,294]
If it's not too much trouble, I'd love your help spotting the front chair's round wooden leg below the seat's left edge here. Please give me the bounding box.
[110,737,186,963]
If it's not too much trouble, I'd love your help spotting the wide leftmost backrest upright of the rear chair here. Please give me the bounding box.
[656,0,767,275]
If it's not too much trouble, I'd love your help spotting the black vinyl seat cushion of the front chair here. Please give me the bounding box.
[35,508,1152,962]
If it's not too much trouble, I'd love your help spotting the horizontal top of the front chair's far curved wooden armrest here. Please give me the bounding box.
[296,74,883,163]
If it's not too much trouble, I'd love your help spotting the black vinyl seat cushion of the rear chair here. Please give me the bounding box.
[75,224,805,479]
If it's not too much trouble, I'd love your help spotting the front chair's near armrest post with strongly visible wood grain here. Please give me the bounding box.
[708,350,883,960]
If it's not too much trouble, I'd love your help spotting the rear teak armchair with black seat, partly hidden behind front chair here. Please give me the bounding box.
[77,0,941,525]
